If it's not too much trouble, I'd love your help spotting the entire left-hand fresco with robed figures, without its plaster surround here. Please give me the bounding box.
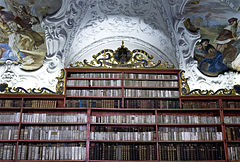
[0,0,61,71]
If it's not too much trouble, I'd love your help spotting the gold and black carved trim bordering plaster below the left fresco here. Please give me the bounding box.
[0,69,66,95]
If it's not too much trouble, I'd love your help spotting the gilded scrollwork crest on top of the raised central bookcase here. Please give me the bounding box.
[70,41,174,69]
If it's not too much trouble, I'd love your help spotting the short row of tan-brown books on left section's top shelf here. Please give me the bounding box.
[24,100,57,108]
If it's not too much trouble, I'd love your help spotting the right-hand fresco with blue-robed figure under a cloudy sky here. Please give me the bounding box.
[184,0,240,77]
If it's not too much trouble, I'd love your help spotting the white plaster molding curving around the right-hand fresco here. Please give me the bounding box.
[172,0,240,91]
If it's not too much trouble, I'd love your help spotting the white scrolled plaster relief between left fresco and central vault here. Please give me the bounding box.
[43,0,88,71]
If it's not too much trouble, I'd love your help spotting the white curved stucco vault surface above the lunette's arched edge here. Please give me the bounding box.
[65,0,178,67]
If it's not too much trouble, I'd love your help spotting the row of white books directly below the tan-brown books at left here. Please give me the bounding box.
[22,113,87,123]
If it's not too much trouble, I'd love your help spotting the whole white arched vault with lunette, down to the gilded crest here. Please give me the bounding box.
[45,0,182,68]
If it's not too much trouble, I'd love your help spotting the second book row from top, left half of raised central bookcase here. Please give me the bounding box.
[67,80,122,87]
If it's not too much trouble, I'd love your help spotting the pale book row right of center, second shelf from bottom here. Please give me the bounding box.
[158,127,222,141]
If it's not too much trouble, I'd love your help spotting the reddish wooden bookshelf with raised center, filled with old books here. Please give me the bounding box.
[0,68,240,162]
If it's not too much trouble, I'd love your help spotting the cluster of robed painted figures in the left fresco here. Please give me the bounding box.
[0,5,46,70]
